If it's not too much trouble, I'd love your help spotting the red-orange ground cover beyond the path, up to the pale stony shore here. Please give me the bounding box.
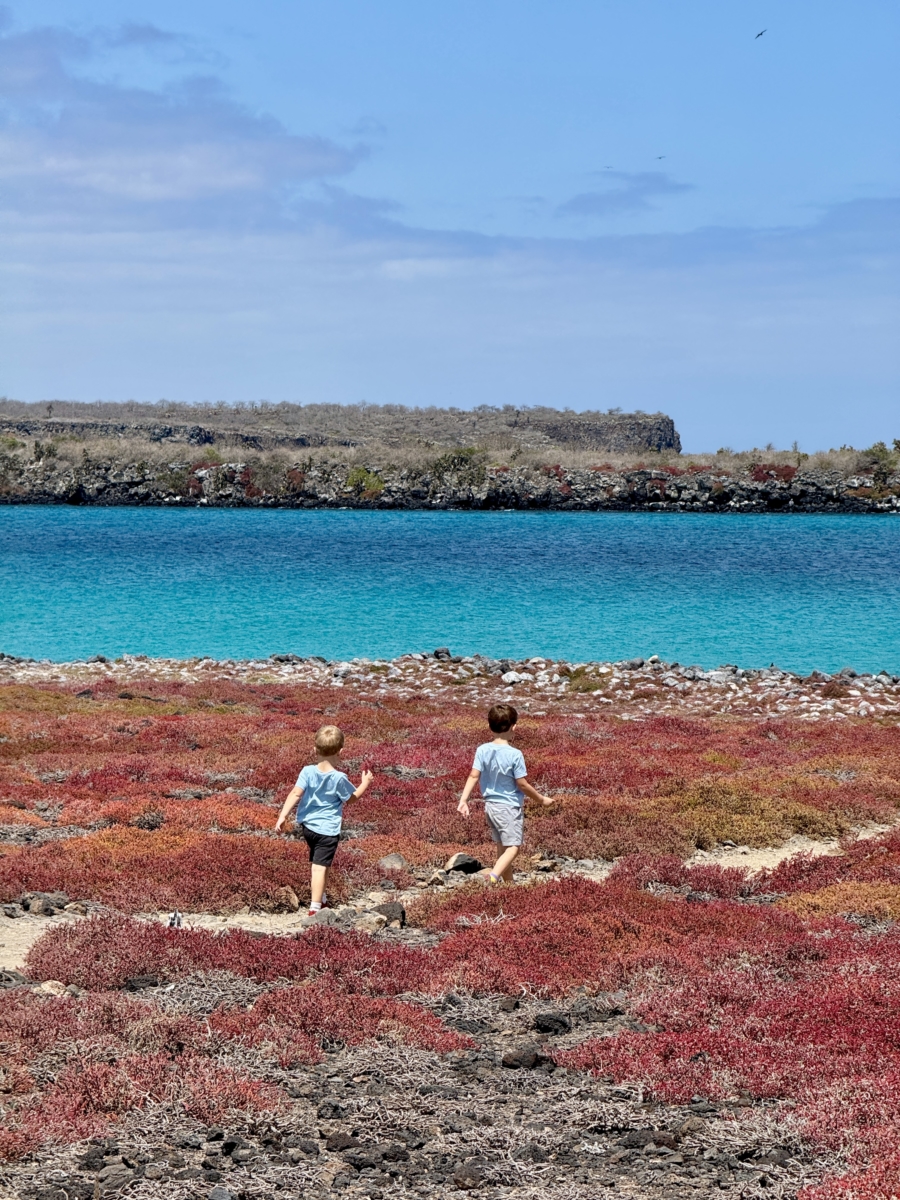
[0,679,900,911]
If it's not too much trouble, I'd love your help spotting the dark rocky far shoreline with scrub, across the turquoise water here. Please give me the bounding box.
[0,451,900,514]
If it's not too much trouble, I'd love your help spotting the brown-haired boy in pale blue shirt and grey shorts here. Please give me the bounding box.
[457,704,553,883]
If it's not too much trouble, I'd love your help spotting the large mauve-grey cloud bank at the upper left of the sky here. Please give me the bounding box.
[0,25,366,224]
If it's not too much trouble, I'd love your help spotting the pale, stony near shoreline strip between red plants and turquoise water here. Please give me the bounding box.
[0,648,900,724]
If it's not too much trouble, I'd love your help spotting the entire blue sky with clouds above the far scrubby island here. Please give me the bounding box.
[0,0,900,450]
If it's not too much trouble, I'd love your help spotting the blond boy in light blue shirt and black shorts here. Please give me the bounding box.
[275,725,374,917]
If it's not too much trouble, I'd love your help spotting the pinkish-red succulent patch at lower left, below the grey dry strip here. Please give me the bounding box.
[0,978,472,1159]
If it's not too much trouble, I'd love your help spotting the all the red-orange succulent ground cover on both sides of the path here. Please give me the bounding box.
[0,680,900,1200]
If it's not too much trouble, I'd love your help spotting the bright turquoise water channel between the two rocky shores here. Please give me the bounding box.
[0,506,900,673]
